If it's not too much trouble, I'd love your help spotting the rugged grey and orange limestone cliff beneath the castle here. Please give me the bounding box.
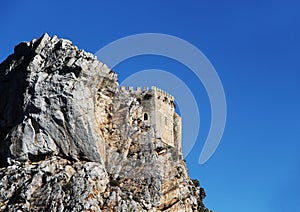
[0,34,207,211]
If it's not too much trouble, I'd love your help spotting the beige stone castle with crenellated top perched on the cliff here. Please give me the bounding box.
[120,86,182,152]
